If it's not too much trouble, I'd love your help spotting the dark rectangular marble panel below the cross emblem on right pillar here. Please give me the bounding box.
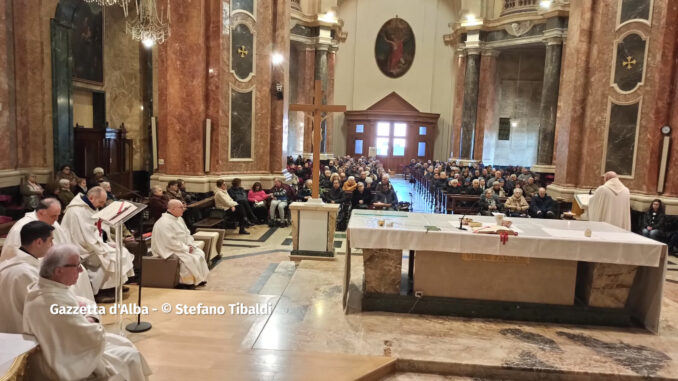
[605,103,640,176]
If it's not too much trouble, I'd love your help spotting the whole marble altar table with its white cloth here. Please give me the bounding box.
[343,210,667,332]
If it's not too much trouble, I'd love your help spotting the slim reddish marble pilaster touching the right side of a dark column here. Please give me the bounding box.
[473,50,498,160]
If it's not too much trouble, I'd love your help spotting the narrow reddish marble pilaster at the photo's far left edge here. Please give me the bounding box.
[0,0,16,170]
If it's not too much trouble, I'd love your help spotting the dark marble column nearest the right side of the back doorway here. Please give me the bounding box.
[459,49,480,159]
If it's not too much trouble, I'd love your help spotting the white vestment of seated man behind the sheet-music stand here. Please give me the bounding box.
[61,196,134,294]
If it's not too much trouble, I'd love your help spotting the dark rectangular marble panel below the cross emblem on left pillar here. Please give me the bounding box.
[230,89,253,159]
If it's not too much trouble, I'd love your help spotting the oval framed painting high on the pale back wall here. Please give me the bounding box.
[374,16,415,78]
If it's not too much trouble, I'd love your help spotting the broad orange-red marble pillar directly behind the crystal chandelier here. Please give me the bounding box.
[158,0,209,175]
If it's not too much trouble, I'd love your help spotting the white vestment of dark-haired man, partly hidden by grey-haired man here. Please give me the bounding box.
[0,249,98,333]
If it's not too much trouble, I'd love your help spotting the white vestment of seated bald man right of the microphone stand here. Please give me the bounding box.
[151,213,209,285]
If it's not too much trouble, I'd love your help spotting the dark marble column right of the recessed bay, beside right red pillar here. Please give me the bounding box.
[537,37,563,165]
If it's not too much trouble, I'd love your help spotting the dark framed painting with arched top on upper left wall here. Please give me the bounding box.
[71,2,104,85]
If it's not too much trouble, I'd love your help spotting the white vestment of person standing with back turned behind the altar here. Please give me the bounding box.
[588,177,631,231]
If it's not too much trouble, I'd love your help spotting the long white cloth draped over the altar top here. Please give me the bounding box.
[347,210,666,267]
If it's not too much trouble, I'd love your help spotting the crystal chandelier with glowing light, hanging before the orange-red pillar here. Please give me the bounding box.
[126,0,170,48]
